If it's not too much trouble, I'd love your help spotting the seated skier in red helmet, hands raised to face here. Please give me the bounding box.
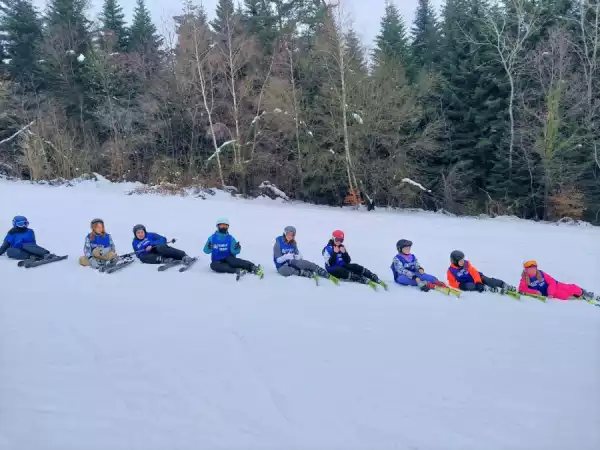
[322,230,387,289]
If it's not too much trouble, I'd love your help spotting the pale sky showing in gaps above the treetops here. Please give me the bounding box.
[34,0,443,47]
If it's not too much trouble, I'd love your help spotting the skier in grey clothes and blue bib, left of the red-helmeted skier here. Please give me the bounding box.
[273,225,339,284]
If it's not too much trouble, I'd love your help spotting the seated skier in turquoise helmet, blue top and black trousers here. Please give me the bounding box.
[204,218,264,278]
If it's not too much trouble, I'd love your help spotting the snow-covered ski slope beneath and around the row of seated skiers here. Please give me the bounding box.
[0,180,600,450]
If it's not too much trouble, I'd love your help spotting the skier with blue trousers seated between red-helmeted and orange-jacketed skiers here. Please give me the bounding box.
[391,239,446,292]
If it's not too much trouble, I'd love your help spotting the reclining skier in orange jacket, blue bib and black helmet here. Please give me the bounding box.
[446,250,516,292]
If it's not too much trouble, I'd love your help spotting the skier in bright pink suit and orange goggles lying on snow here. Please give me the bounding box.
[519,260,598,300]
